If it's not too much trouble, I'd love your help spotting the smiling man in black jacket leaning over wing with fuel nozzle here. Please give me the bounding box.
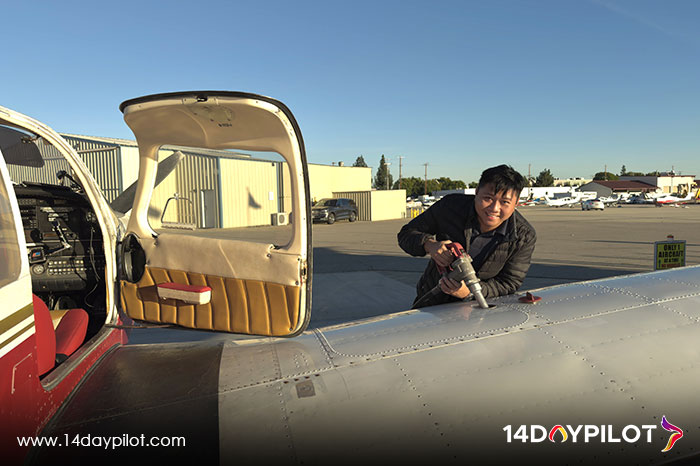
[398,165,537,306]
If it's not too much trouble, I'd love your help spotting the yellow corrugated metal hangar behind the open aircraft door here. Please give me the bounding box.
[9,134,406,228]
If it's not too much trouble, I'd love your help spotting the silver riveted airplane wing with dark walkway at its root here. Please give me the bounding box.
[35,267,700,464]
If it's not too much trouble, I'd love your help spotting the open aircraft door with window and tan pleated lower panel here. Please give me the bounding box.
[120,91,312,336]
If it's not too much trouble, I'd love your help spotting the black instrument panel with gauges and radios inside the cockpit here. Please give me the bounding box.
[15,183,105,292]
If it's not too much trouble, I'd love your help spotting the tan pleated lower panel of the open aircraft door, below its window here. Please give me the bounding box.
[121,231,302,336]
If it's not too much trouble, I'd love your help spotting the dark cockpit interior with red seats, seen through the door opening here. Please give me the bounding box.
[0,125,107,372]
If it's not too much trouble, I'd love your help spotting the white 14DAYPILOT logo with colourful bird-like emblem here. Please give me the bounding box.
[503,416,683,452]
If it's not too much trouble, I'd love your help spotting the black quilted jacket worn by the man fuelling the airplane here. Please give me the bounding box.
[398,194,537,305]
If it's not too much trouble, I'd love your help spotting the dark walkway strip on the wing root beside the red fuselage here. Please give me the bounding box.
[32,343,223,464]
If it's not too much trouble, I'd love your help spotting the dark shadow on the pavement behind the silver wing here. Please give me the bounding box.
[123,248,640,344]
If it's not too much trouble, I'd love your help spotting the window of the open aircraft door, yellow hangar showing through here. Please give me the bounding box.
[148,146,294,246]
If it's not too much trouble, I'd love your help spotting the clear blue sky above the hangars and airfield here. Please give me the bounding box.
[0,0,700,182]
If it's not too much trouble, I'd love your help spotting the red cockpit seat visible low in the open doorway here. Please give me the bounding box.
[32,295,89,375]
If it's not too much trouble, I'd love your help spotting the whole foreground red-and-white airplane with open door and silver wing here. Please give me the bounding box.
[0,91,700,464]
